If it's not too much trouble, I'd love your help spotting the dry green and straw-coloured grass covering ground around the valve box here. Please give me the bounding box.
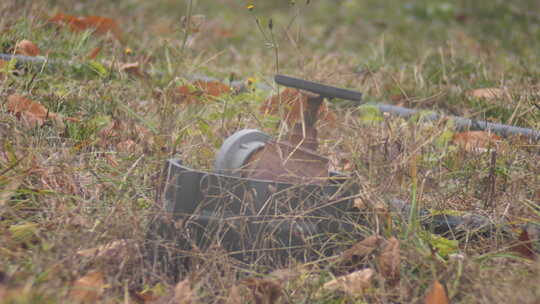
[0,0,540,303]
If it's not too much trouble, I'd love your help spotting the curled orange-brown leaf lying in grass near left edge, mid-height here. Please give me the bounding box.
[7,94,58,126]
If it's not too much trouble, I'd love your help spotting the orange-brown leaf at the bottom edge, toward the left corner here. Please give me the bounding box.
[69,271,105,303]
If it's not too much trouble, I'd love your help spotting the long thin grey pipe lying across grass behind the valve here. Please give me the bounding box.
[0,54,540,140]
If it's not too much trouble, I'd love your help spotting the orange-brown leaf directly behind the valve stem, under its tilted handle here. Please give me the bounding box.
[260,88,337,126]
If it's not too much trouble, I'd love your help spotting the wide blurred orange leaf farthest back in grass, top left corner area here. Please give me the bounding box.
[49,13,122,40]
